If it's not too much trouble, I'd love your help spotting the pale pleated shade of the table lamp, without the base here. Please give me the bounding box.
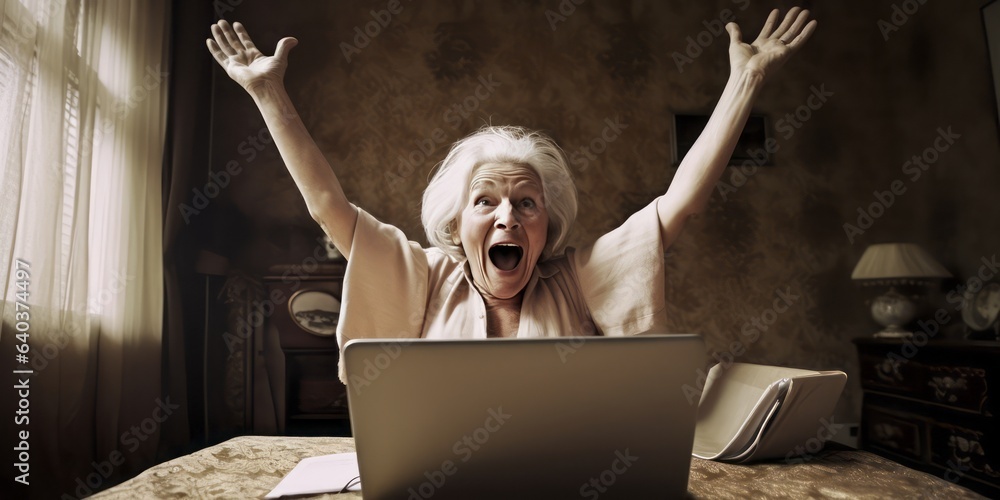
[851,243,951,280]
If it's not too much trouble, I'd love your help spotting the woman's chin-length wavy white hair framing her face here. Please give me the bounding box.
[420,126,577,261]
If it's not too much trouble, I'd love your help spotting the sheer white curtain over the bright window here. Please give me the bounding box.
[0,0,169,495]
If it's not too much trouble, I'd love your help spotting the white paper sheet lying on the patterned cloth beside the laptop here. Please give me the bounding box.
[264,453,361,498]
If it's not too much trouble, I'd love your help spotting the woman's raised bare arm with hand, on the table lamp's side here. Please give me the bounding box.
[657,7,816,248]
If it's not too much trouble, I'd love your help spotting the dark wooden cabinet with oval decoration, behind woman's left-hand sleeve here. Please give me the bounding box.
[258,264,350,436]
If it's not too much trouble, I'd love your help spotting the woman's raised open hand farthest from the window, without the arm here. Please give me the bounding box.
[726,7,816,77]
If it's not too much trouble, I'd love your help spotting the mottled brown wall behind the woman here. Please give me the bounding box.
[204,0,1000,426]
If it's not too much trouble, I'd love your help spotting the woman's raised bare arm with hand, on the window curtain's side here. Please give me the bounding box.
[207,20,358,258]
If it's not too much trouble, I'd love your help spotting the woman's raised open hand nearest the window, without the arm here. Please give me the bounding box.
[206,19,299,91]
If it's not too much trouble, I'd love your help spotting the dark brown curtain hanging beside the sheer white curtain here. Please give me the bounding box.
[160,0,215,459]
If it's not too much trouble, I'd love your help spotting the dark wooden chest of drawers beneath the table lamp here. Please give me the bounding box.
[854,338,1000,497]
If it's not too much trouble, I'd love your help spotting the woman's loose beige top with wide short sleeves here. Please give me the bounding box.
[337,202,666,383]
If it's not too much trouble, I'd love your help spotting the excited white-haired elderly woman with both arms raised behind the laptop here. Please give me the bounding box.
[208,8,816,381]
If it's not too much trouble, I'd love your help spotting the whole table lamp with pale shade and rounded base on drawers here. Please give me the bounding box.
[851,243,951,338]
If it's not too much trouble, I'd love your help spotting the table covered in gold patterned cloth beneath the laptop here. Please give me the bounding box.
[94,436,983,500]
